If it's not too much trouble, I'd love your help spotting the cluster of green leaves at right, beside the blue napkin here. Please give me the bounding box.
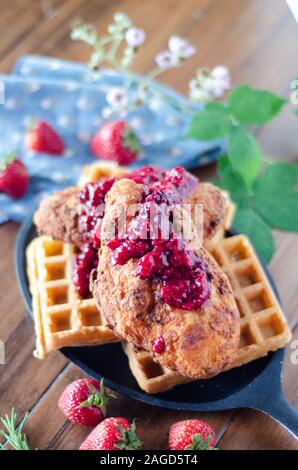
[187,85,298,262]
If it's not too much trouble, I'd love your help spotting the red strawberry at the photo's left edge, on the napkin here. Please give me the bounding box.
[0,153,29,199]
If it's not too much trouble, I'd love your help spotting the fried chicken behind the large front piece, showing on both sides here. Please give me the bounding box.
[34,179,227,246]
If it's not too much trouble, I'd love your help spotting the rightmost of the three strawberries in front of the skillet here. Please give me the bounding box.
[169,419,216,450]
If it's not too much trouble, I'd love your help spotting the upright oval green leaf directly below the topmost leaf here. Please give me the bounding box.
[228,126,262,184]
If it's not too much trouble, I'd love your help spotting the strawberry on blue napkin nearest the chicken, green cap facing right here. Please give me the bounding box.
[90,121,141,165]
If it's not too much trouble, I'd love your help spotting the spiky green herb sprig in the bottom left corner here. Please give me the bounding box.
[0,408,30,450]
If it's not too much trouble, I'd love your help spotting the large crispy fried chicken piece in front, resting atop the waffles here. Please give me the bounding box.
[91,179,240,379]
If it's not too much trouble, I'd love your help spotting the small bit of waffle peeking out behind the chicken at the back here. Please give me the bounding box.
[79,161,128,186]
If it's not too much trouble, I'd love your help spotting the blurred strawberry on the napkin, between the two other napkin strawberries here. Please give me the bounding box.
[25,121,65,155]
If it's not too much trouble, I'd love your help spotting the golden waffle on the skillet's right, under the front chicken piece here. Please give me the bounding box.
[124,235,291,393]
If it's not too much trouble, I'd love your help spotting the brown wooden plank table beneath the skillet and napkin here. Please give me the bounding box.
[0,0,298,449]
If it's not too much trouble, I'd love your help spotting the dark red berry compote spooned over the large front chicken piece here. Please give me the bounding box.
[107,167,210,310]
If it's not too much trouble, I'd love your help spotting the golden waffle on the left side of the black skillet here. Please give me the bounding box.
[26,237,119,359]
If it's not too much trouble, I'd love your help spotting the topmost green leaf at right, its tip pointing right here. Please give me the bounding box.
[228,85,287,124]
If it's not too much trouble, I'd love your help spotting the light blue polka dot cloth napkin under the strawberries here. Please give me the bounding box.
[0,56,222,223]
